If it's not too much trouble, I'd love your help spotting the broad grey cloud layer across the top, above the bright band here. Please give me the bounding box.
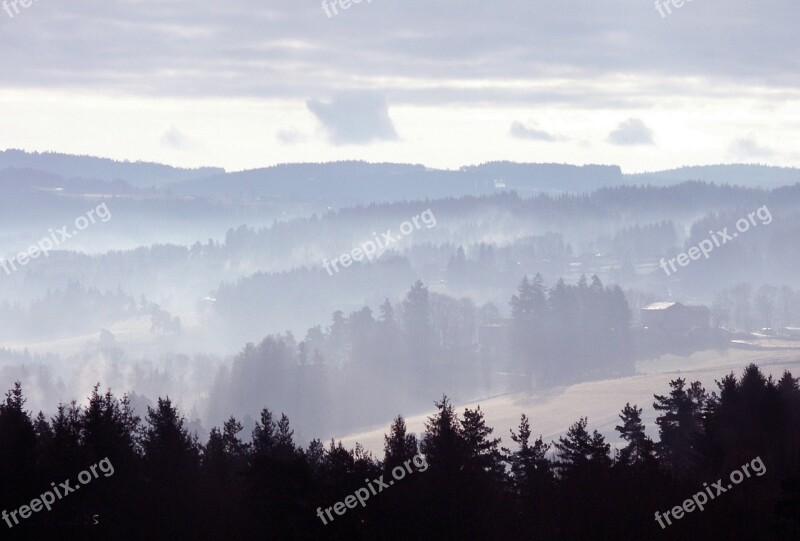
[0,0,800,107]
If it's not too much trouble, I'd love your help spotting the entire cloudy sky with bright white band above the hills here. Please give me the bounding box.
[0,0,800,172]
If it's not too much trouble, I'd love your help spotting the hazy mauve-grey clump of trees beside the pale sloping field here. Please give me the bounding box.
[209,273,633,433]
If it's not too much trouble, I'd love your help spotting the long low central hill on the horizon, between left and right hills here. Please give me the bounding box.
[170,161,623,203]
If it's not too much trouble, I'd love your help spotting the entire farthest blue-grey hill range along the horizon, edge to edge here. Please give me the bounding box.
[0,150,800,202]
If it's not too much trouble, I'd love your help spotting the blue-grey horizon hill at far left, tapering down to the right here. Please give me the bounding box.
[0,149,225,188]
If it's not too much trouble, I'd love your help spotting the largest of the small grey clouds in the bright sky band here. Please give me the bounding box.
[306,92,398,145]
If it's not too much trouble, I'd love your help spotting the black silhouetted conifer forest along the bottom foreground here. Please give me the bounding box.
[0,365,800,541]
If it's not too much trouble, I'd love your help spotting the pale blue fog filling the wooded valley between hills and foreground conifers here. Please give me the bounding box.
[0,155,800,436]
